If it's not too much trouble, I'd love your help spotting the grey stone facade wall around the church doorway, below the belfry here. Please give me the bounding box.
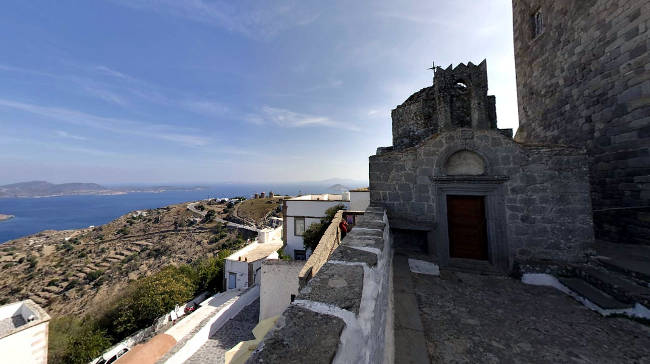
[370,129,593,261]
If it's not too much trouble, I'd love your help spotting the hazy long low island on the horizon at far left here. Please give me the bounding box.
[0,181,205,198]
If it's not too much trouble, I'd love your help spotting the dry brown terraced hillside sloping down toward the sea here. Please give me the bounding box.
[0,200,246,316]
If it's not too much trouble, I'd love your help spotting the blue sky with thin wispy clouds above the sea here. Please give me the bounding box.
[0,0,517,184]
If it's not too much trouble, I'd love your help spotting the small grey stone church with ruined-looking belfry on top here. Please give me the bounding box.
[369,61,593,271]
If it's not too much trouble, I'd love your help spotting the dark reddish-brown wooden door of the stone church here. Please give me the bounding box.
[447,195,488,260]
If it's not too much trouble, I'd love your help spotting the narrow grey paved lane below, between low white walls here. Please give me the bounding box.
[185,298,260,364]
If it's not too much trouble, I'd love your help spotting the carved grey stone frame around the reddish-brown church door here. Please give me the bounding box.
[432,176,511,272]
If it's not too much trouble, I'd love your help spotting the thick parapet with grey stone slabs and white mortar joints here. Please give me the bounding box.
[248,206,393,363]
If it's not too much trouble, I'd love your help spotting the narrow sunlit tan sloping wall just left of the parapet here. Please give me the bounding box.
[298,210,343,287]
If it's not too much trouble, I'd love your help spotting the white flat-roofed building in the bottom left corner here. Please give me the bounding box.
[0,300,50,363]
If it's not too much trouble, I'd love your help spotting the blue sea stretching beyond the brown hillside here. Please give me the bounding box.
[0,183,357,244]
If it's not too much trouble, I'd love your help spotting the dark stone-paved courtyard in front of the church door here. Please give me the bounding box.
[411,270,650,363]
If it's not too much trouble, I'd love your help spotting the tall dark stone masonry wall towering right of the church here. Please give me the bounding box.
[513,0,650,244]
